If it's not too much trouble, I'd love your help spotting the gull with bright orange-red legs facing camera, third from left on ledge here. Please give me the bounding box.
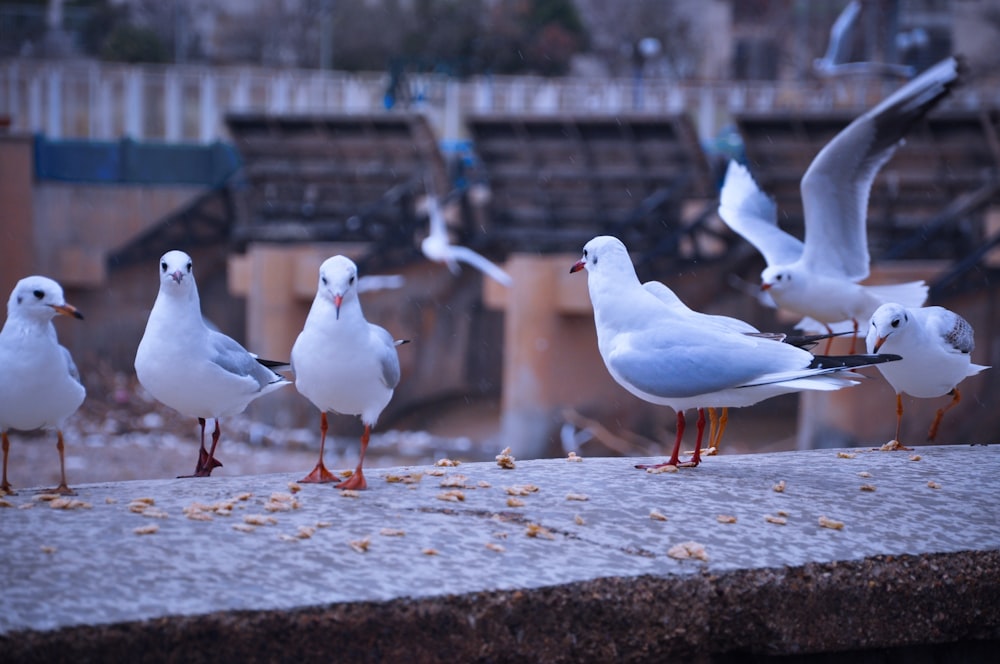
[292,256,406,489]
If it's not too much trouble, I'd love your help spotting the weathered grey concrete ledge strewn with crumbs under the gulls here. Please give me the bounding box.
[0,446,1000,661]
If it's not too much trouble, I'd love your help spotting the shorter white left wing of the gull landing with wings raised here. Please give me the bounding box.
[719,161,803,265]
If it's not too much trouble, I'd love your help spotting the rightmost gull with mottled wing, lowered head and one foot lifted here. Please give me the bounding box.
[865,302,989,449]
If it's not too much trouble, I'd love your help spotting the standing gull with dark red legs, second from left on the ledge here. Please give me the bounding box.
[135,250,291,477]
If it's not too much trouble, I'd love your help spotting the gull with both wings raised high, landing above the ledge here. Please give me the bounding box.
[719,58,959,353]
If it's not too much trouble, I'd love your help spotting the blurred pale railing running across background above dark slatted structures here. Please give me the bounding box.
[0,58,1000,143]
